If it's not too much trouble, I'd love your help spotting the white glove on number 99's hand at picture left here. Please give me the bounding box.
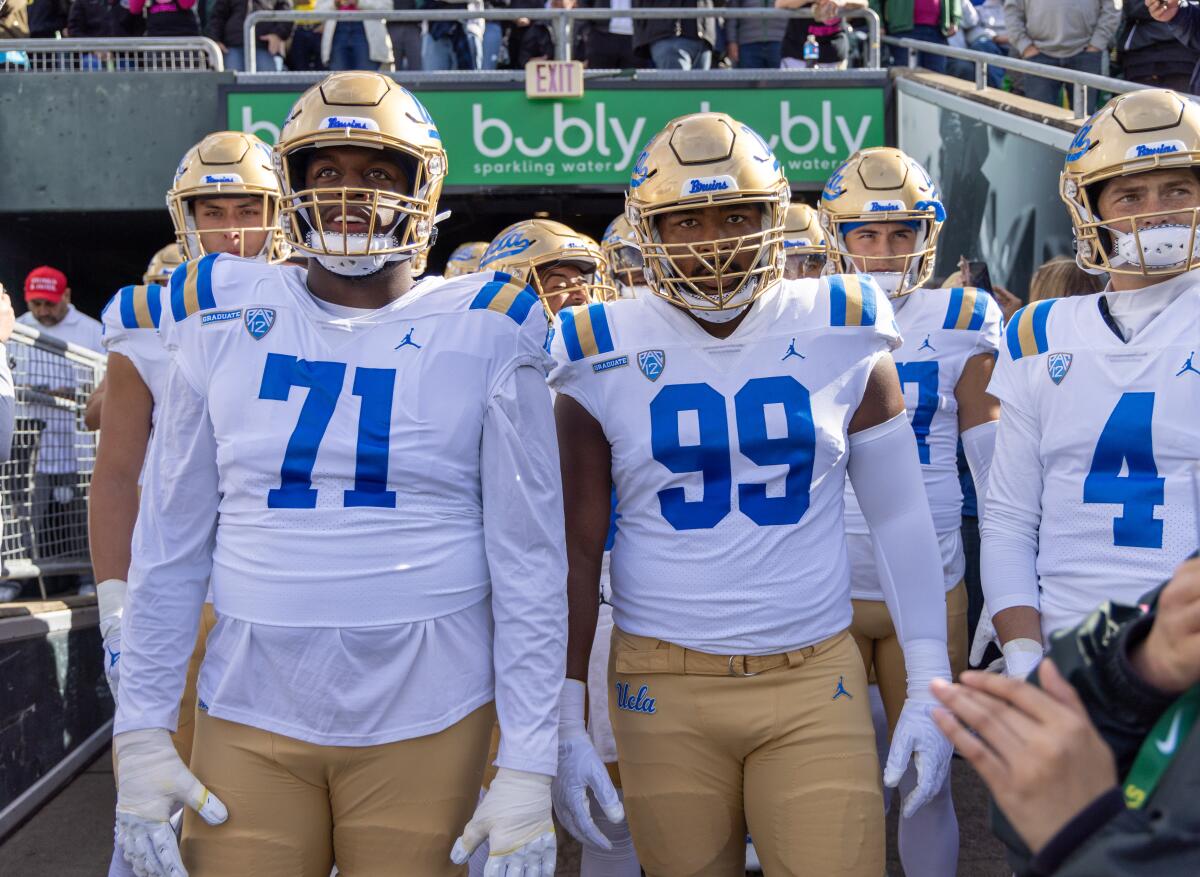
[551,679,625,849]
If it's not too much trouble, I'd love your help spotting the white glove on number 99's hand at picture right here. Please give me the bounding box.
[883,639,954,816]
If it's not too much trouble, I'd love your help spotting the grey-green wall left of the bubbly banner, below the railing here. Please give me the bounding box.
[0,72,234,214]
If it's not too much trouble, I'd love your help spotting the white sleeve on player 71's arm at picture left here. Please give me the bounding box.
[113,364,220,734]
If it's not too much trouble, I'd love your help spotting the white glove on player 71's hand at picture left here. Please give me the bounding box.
[113,728,229,877]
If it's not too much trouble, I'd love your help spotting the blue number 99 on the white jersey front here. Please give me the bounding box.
[650,376,816,530]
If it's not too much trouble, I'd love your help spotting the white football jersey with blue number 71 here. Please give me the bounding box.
[163,250,548,627]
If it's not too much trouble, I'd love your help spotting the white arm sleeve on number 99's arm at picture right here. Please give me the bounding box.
[847,414,950,697]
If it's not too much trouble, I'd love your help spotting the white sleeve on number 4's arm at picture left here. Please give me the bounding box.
[979,402,1042,617]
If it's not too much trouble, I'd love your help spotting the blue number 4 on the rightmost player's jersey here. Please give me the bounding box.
[1084,392,1166,548]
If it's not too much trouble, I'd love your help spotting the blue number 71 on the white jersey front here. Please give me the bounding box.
[258,353,396,509]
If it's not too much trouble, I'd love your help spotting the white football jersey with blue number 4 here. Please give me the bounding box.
[988,284,1200,631]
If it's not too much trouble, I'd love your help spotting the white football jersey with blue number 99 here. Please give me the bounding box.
[551,275,900,654]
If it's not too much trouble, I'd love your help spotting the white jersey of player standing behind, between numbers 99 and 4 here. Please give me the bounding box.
[846,287,1003,600]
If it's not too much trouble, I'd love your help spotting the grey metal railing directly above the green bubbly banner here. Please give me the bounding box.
[242,7,880,73]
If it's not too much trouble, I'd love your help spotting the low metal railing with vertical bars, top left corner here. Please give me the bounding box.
[0,36,224,73]
